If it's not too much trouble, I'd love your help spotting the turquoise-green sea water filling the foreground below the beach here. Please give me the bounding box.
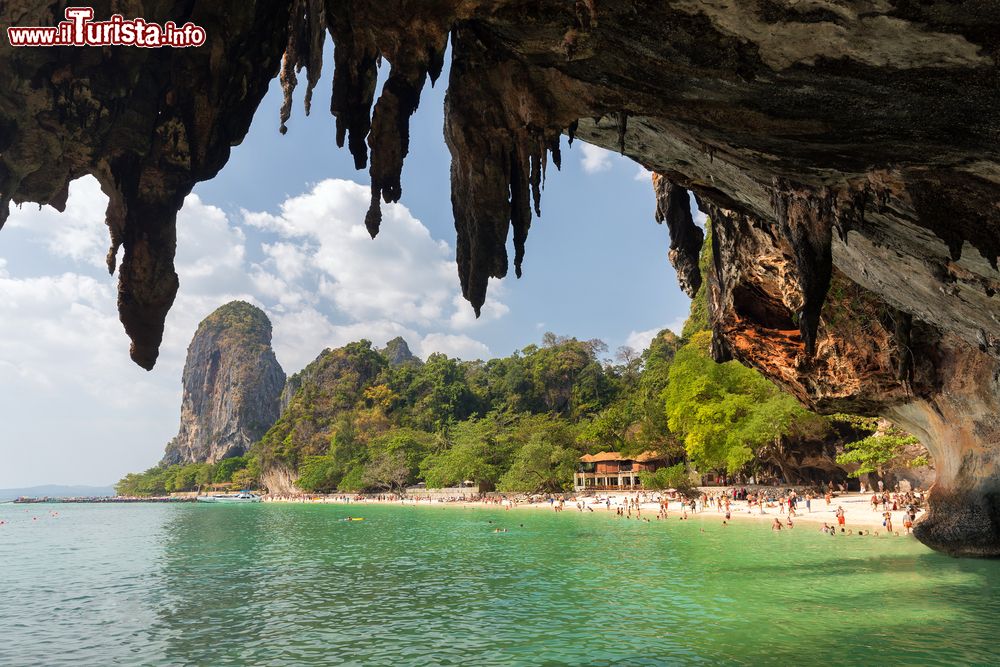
[0,504,1000,665]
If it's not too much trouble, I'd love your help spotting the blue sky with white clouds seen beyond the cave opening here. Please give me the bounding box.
[0,45,689,488]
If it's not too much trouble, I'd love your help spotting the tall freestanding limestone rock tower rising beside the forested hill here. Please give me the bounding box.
[163,301,285,463]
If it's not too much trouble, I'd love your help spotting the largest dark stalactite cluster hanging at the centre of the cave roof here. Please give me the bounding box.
[445,29,578,314]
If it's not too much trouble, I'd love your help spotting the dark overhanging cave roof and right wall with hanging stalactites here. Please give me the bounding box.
[0,0,1000,556]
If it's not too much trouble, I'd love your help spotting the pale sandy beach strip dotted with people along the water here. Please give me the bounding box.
[264,493,924,537]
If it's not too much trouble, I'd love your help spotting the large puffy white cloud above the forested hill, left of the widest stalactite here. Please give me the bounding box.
[243,179,508,327]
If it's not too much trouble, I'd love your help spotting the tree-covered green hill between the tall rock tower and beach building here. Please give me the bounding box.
[247,334,628,492]
